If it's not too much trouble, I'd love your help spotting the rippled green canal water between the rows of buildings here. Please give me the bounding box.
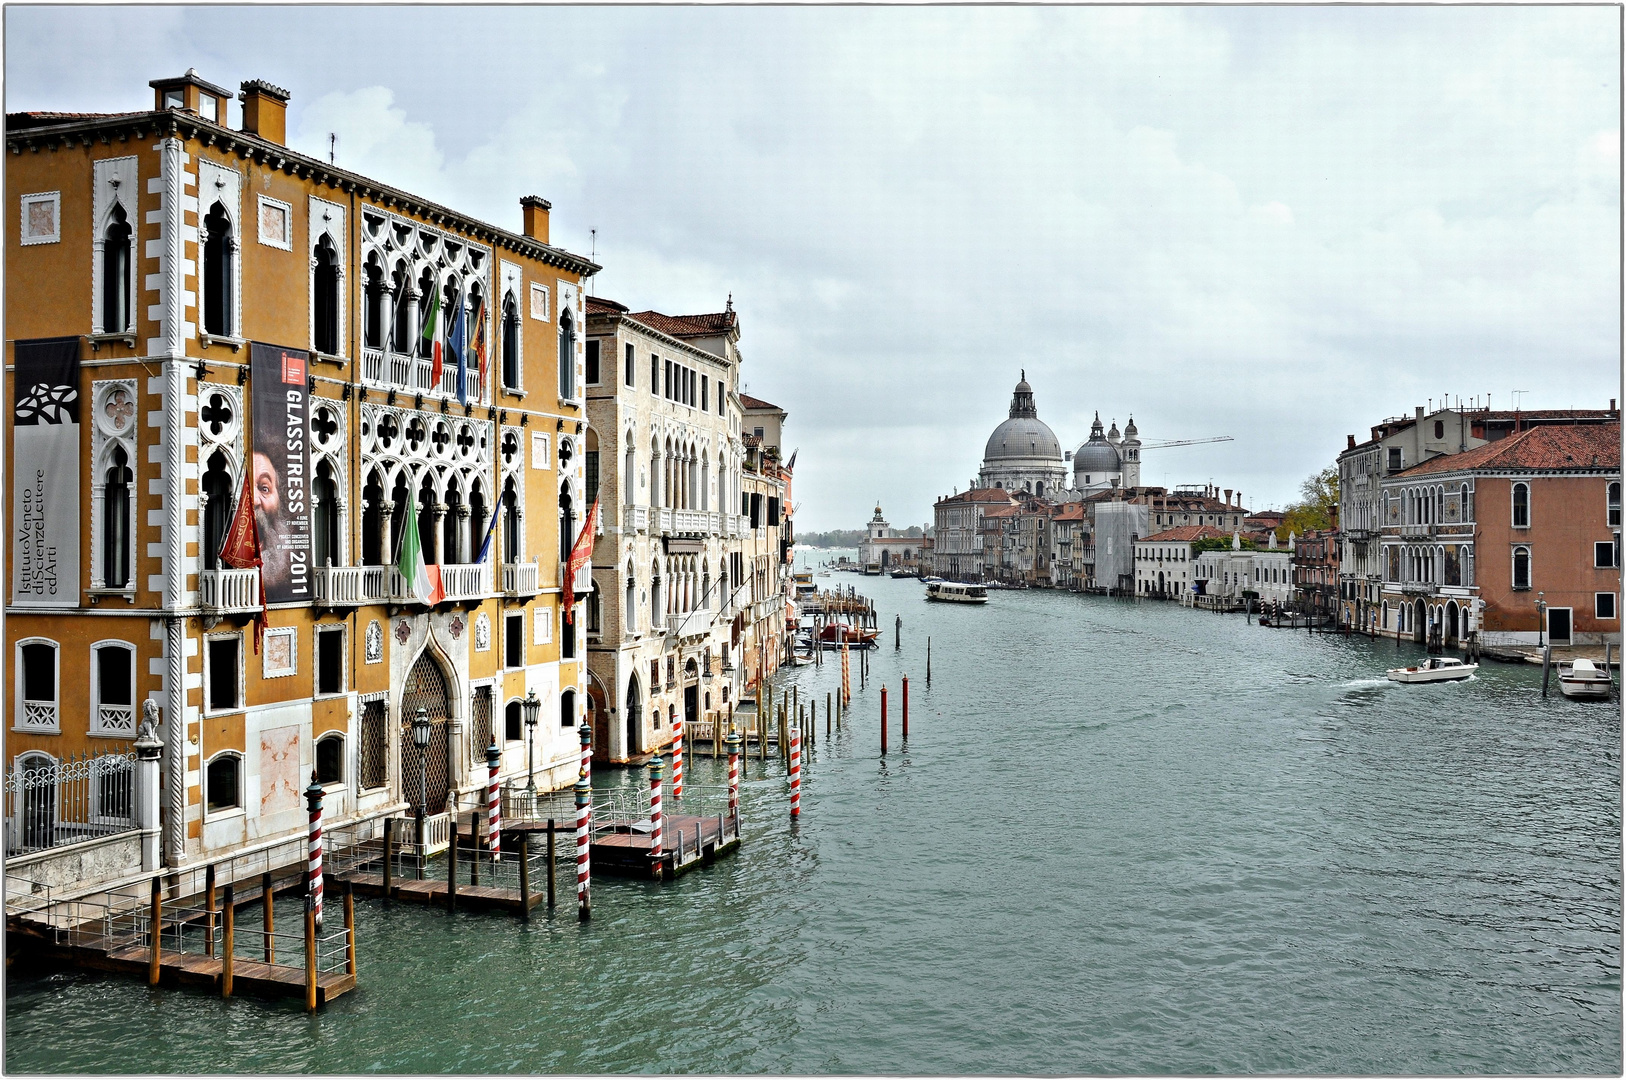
[5,553,1621,1075]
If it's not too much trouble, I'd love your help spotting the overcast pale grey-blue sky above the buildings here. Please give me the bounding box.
[5,7,1621,529]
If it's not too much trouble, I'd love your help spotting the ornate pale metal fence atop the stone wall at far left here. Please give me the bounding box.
[5,750,138,856]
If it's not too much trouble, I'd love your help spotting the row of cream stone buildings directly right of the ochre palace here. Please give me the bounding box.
[587,296,785,761]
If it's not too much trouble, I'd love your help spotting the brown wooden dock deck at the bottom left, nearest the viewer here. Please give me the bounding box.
[8,938,356,1008]
